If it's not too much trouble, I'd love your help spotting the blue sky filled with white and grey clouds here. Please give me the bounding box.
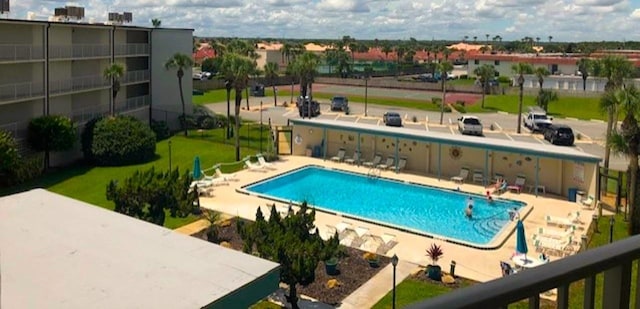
[9,0,640,42]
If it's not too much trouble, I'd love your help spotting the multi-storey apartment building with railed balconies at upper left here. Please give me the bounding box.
[0,19,193,140]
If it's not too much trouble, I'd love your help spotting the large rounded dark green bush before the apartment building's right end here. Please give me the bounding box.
[86,116,156,166]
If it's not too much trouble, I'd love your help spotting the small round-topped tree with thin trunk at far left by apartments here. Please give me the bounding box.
[27,115,77,169]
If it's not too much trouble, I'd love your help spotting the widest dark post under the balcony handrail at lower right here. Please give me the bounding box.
[602,261,631,308]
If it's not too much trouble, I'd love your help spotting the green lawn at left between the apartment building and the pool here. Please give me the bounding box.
[0,125,269,229]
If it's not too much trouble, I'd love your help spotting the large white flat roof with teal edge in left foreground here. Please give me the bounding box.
[0,189,280,309]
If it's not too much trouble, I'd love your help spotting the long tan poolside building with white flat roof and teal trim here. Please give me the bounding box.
[290,119,601,201]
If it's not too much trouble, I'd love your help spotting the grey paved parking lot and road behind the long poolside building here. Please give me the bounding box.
[202,85,628,170]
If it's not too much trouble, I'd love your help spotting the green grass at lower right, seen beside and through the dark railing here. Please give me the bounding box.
[373,215,637,309]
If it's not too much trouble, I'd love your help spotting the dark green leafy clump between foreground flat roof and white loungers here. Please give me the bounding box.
[107,167,197,225]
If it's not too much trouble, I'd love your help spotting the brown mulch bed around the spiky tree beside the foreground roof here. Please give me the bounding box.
[193,218,391,306]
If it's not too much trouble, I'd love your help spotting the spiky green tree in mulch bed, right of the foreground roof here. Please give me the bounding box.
[240,202,337,309]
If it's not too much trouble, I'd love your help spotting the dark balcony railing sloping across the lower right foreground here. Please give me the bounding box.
[408,236,640,309]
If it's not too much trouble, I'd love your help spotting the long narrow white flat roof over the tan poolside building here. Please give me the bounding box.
[290,119,602,164]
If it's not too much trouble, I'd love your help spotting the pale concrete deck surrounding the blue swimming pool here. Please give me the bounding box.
[200,156,595,308]
